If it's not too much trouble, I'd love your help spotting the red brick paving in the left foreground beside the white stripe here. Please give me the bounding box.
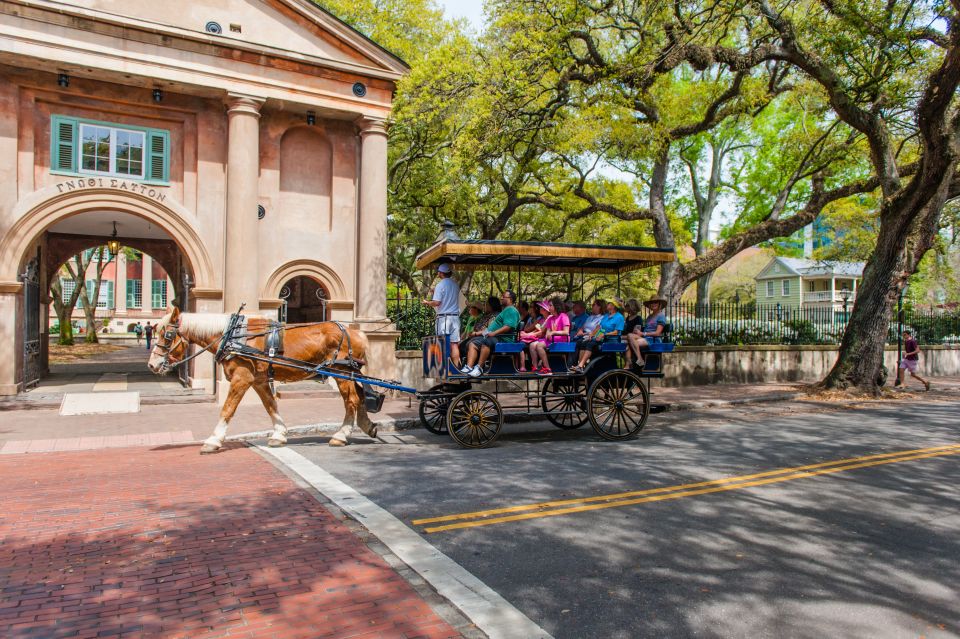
[0,445,459,639]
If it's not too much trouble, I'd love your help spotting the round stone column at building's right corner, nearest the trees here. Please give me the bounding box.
[356,118,387,321]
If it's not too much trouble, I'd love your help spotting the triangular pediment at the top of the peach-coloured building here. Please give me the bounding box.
[0,0,408,80]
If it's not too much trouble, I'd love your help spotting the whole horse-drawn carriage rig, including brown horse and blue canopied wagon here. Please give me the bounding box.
[147,238,675,453]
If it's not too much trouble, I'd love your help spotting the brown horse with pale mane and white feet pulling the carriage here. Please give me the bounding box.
[147,308,377,453]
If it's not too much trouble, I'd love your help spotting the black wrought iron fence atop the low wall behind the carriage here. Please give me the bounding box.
[387,297,960,350]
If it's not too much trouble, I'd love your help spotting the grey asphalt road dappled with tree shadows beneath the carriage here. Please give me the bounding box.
[286,401,960,639]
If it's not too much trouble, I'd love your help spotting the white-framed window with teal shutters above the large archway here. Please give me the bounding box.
[50,115,170,183]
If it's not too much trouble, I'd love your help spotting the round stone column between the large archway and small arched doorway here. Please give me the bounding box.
[223,94,263,313]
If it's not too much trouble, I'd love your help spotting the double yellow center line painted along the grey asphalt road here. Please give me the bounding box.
[412,444,960,533]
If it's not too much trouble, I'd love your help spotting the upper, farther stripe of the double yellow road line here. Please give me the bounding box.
[411,444,960,526]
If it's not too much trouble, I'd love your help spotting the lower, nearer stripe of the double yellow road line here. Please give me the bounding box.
[413,444,960,533]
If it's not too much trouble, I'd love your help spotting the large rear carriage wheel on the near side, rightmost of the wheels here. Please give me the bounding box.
[587,370,650,441]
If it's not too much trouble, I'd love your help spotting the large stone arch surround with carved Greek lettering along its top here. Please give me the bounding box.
[0,178,222,395]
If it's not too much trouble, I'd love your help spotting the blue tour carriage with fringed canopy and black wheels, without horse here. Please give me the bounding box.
[416,238,676,448]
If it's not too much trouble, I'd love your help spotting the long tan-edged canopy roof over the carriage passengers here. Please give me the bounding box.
[416,239,676,273]
